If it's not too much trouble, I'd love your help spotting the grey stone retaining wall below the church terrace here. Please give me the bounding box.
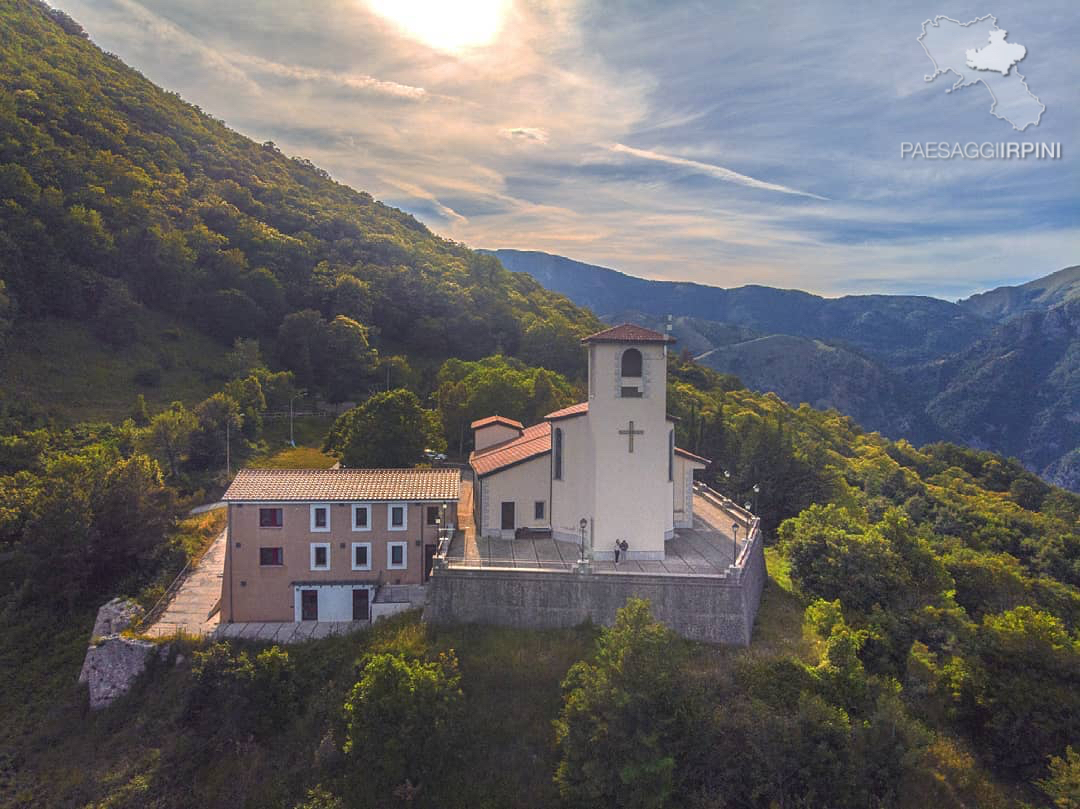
[423,534,766,646]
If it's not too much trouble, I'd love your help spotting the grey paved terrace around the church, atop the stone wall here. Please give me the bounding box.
[447,494,745,576]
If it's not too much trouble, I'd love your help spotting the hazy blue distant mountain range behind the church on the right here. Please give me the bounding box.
[491,250,1080,490]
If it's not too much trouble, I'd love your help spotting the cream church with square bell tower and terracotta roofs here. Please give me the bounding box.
[469,324,708,561]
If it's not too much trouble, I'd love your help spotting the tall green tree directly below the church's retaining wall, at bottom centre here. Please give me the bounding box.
[555,598,688,809]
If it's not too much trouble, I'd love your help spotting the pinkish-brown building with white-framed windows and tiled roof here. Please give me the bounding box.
[221,469,460,622]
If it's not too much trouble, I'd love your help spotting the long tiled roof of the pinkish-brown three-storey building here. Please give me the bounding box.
[221,469,461,502]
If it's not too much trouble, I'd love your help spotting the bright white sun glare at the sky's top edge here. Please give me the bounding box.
[367,0,511,53]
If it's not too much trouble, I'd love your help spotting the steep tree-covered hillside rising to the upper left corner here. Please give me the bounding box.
[0,0,595,425]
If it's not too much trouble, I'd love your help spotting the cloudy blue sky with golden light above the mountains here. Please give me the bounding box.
[51,0,1080,299]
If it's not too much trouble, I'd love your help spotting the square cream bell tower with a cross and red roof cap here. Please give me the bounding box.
[582,324,674,559]
